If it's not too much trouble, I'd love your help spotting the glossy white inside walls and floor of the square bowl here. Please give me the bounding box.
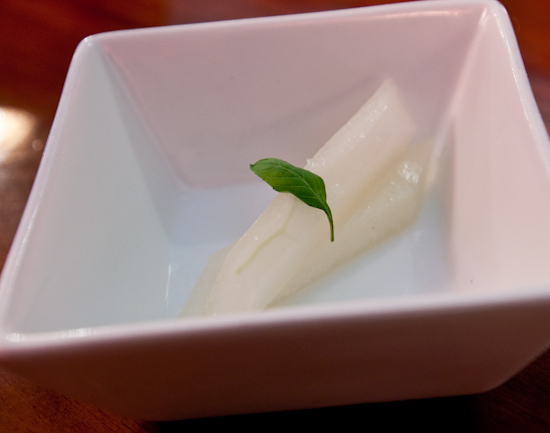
[2,1,550,333]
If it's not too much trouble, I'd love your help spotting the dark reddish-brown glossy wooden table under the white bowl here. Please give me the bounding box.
[0,0,550,433]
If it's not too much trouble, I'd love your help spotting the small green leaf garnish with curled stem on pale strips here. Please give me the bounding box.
[250,158,334,242]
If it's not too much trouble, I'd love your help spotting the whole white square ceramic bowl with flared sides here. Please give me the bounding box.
[0,0,550,420]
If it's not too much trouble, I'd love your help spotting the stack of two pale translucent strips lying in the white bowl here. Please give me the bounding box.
[181,80,425,316]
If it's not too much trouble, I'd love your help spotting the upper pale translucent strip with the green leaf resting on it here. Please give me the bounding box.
[184,80,416,314]
